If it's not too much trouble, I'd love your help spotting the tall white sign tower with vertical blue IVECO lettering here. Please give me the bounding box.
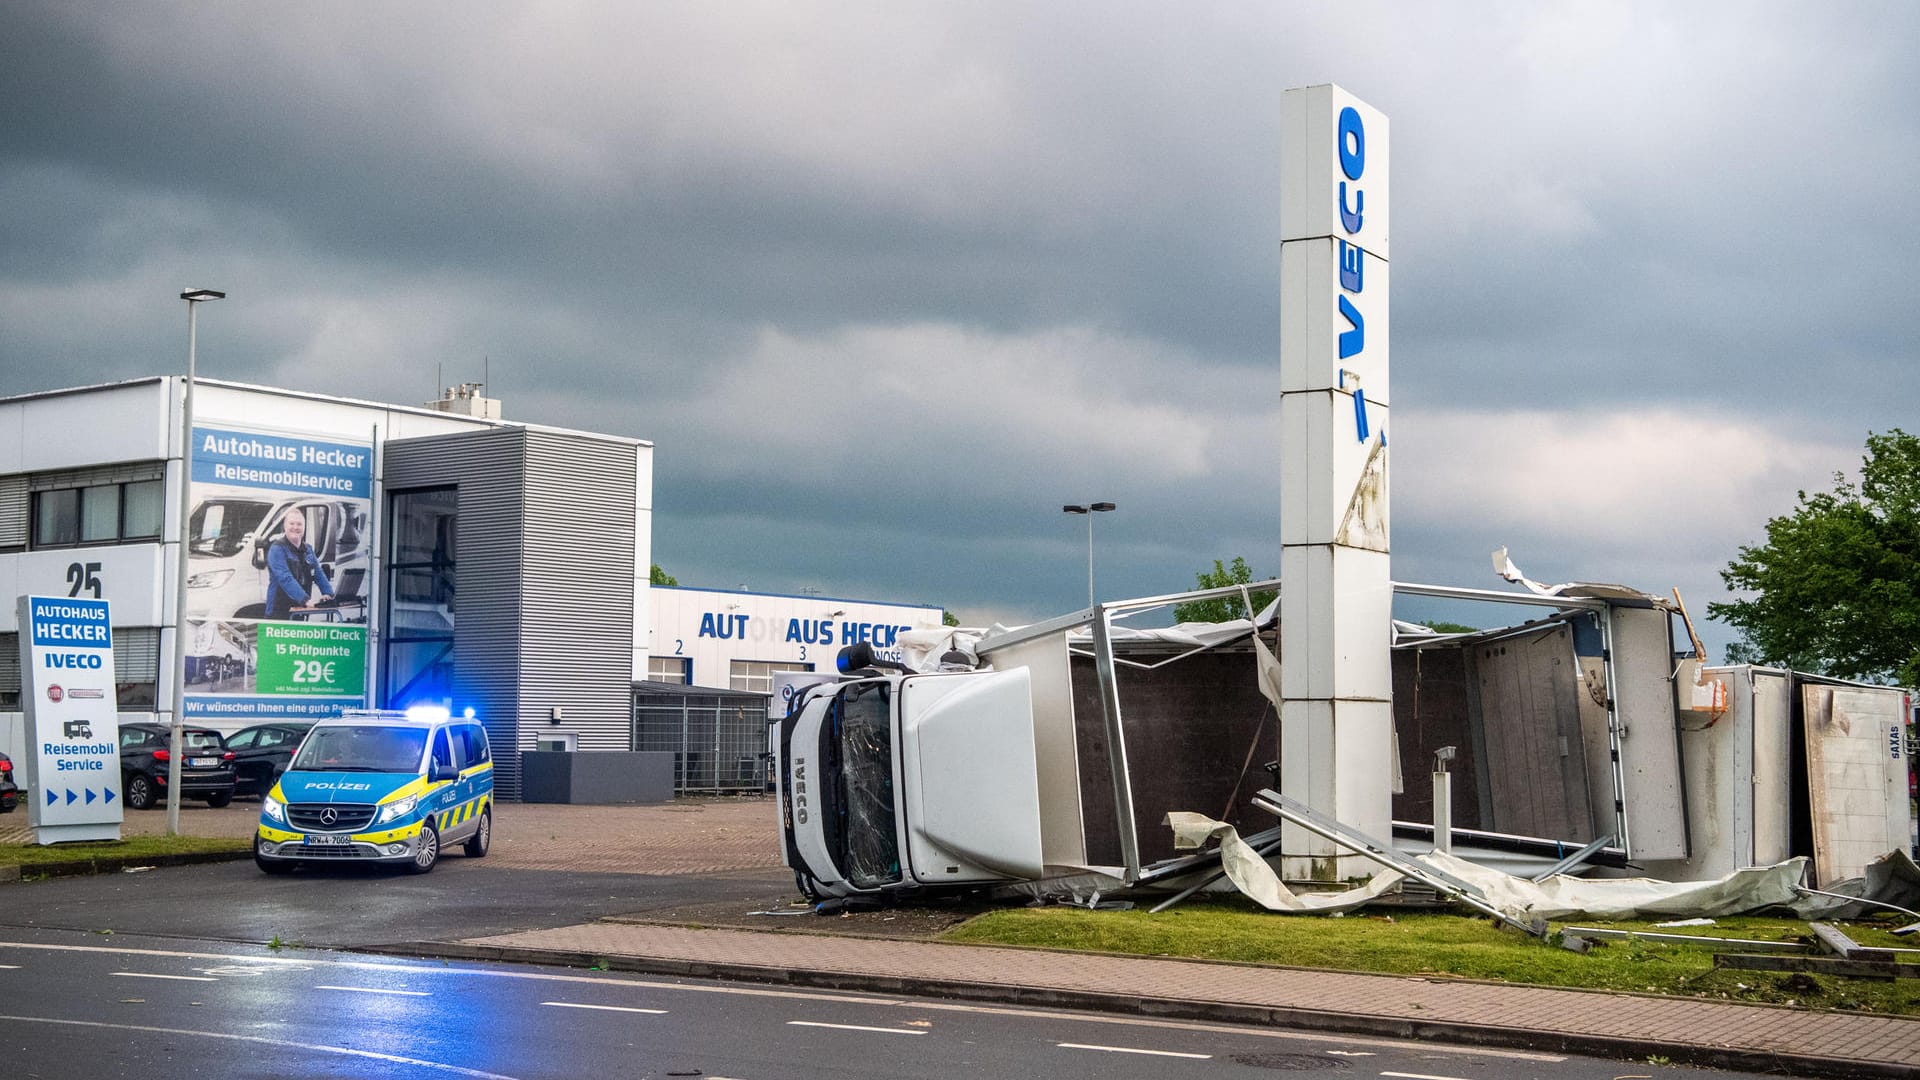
[1281,85,1396,880]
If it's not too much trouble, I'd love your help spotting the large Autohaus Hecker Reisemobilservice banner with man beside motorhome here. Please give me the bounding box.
[186,427,372,726]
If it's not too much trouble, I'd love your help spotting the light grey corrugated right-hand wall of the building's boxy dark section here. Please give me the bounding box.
[518,430,637,749]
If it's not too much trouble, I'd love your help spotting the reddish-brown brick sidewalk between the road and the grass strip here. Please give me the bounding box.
[408,922,1920,1076]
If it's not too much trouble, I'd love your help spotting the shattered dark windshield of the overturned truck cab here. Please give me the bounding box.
[820,682,900,888]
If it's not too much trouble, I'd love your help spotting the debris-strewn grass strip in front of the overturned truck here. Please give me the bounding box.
[941,899,1920,1015]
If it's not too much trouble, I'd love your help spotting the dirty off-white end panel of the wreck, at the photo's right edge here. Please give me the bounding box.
[1801,686,1908,888]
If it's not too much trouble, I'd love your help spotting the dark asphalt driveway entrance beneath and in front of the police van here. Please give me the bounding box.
[0,853,793,947]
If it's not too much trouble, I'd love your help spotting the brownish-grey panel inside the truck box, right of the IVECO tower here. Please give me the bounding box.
[1471,626,1596,842]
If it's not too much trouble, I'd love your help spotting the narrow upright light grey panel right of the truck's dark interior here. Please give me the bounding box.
[1609,607,1688,859]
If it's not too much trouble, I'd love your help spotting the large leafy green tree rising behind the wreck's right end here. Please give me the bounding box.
[1707,429,1920,686]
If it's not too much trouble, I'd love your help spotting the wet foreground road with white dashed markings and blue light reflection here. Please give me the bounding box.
[0,930,1766,1080]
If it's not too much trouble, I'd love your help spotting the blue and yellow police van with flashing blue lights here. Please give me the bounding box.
[253,707,493,874]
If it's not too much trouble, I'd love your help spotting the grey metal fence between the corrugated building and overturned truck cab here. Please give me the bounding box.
[634,682,772,796]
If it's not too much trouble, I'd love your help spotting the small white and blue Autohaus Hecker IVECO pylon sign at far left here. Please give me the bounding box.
[19,596,123,844]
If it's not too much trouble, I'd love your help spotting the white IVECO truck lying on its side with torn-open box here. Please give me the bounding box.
[772,582,1910,897]
